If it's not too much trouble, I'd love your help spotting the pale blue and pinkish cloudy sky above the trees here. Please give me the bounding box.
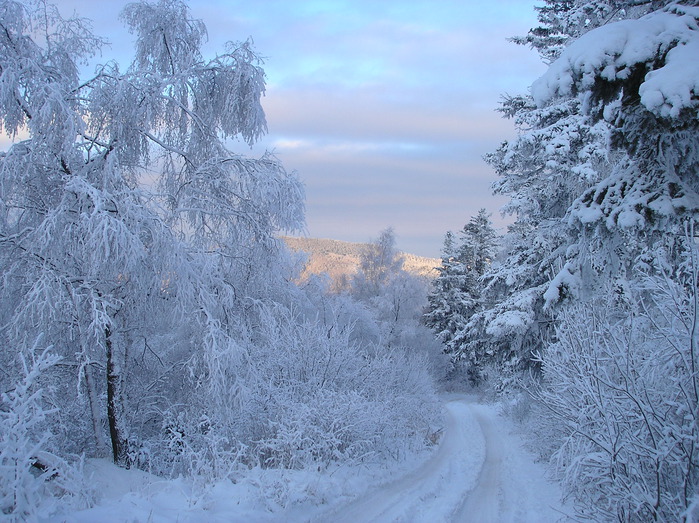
[56,0,545,257]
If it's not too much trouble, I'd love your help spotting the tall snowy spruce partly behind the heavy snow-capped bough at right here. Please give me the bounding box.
[464,0,672,380]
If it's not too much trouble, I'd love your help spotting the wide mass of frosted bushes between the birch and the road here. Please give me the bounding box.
[149,296,439,480]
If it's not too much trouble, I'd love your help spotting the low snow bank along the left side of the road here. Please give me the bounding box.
[43,451,442,523]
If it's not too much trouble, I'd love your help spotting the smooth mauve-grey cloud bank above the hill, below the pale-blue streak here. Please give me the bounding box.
[274,135,516,256]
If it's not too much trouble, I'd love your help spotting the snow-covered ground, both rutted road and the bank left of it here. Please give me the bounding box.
[49,395,570,523]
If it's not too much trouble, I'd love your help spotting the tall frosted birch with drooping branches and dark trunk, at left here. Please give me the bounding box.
[0,1,303,464]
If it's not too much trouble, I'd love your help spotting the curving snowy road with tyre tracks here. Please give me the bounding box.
[318,396,562,523]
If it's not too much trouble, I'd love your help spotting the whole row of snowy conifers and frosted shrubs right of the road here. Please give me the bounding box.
[427,0,699,521]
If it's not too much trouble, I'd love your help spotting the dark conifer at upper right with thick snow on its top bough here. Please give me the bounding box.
[495,1,697,308]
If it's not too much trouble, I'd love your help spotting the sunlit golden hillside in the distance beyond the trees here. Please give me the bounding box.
[282,237,441,285]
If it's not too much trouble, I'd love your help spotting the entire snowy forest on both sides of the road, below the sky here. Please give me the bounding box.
[0,0,699,522]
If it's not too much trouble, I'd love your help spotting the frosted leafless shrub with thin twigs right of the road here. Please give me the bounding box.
[539,249,699,521]
